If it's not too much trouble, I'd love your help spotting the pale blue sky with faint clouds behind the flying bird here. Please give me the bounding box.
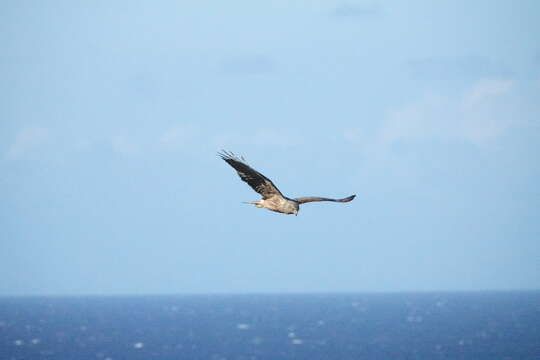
[0,0,540,296]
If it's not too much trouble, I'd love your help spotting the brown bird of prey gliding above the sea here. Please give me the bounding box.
[218,150,356,215]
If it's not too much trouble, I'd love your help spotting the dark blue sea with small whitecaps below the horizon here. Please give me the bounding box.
[0,292,540,360]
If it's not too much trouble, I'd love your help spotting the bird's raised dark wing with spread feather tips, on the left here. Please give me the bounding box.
[218,150,283,199]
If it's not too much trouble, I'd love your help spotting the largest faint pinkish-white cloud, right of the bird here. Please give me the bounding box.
[379,79,520,145]
